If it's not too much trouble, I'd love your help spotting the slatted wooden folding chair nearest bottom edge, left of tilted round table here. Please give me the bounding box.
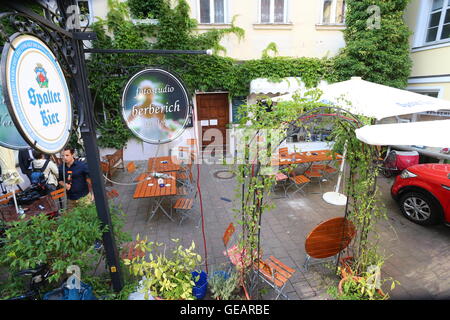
[255,256,296,300]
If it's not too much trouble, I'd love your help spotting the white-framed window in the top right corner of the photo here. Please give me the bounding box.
[425,0,450,43]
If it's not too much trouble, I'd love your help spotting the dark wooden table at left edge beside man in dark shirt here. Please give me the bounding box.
[0,196,58,222]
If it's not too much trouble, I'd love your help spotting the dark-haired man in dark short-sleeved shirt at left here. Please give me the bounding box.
[58,148,93,210]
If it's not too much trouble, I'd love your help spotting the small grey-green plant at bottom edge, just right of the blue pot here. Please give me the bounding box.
[208,271,239,300]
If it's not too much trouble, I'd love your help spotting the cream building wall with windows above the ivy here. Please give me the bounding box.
[78,0,345,60]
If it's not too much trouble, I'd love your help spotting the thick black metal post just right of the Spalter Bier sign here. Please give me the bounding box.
[73,35,123,292]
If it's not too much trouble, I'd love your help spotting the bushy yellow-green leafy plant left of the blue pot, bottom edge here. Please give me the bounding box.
[123,235,202,300]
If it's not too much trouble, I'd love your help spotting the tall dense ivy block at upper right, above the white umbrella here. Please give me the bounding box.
[334,0,412,89]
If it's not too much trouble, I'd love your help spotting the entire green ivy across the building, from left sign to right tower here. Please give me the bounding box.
[88,0,411,148]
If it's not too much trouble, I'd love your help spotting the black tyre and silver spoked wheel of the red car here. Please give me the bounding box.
[399,192,441,226]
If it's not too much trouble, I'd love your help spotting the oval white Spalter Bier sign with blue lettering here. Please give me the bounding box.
[2,35,72,153]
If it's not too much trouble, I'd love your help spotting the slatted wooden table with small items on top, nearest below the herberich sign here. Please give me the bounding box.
[133,172,177,221]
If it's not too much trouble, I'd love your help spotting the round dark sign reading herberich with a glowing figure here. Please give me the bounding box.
[122,68,189,144]
